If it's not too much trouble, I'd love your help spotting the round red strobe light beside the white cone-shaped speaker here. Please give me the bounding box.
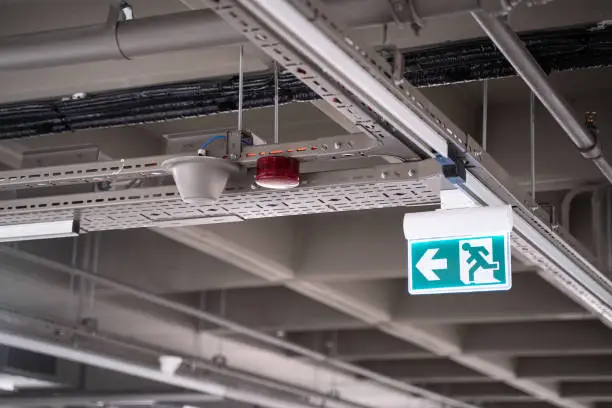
[255,156,300,190]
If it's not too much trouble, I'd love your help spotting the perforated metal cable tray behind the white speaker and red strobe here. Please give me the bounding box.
[0,159,441,231]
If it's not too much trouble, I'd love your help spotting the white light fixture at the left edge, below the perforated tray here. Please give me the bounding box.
[0,220,79,242]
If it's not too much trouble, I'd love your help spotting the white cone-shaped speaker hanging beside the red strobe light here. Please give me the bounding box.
[162,156,239,205]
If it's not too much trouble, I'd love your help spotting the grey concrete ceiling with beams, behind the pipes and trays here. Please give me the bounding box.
[0,0,612,408]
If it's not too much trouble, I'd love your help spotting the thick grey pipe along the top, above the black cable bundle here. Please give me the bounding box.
[0,0,504,70]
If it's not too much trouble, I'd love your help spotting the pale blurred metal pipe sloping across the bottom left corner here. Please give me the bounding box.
[0,331,326,408]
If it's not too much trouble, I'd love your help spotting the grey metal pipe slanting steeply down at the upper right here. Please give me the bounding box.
[472,10,612,182]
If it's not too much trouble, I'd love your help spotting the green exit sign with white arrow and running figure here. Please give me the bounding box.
[404,207,512,295]
